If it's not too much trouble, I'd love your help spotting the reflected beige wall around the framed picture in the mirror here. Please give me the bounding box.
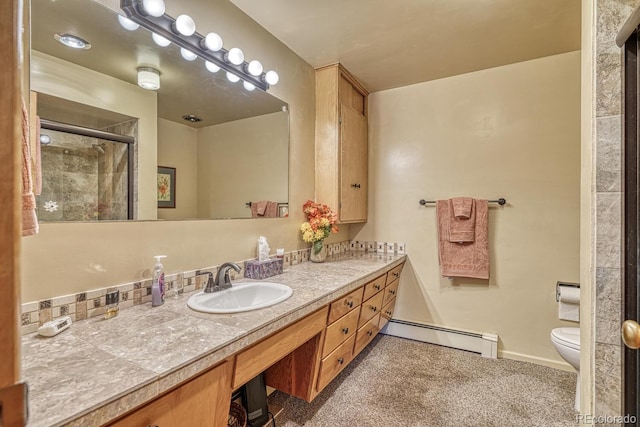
[158,119,198,219]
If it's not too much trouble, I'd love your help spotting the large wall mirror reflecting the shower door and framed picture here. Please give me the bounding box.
[30,0,289,221]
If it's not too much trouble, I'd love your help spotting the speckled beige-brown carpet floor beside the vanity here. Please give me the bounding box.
[270,335,577,427]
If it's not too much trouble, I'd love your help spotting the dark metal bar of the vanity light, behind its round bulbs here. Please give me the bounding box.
[120,0,269,91]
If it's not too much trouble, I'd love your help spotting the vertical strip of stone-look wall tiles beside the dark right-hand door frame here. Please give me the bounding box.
[592,0,640,415]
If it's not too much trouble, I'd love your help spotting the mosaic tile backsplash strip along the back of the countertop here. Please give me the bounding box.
[20,241,406,335]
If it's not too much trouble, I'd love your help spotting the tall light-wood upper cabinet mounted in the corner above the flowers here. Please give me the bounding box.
[316,64,369,223]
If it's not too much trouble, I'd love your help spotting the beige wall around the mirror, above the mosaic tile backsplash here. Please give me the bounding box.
[21,0,349,302]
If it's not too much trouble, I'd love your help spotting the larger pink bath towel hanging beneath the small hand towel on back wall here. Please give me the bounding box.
[436,200,489,279]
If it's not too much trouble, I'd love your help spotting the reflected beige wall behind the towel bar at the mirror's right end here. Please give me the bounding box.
[198,112,289,218]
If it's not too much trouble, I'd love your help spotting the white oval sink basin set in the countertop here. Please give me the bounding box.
[187,282,293,313]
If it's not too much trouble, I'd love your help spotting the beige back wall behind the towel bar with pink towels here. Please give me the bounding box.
[351,52,580,367]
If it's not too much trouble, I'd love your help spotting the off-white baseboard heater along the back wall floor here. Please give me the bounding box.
[380,319,498,359]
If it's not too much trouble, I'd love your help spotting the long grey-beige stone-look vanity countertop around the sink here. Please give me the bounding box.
[22,252,406,427]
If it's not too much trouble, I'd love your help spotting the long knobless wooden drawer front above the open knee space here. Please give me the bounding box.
[233,306,327,389]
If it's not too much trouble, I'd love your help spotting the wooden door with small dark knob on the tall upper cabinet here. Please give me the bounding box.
[338,104,368,222]
